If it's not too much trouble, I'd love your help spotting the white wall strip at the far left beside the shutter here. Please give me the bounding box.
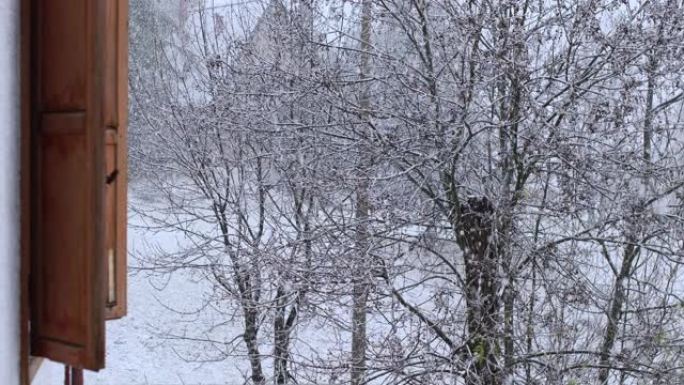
[0,0,20,385]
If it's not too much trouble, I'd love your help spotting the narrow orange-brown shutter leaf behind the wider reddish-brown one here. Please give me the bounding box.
[103,0,128,319]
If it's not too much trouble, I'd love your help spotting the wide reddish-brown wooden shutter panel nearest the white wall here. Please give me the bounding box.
[30,0,106,370]
